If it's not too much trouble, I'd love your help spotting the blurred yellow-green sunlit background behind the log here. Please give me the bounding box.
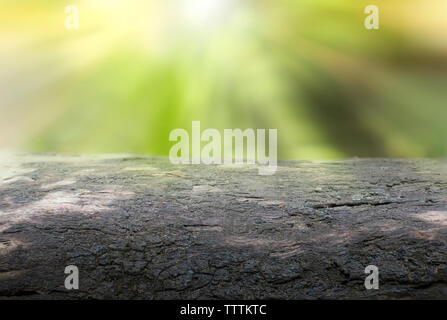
[0,0,447,159]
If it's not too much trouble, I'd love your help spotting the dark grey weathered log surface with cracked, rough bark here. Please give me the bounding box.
[0,154,447,299]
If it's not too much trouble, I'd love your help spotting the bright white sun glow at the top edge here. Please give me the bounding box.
[181,0,232,27]
